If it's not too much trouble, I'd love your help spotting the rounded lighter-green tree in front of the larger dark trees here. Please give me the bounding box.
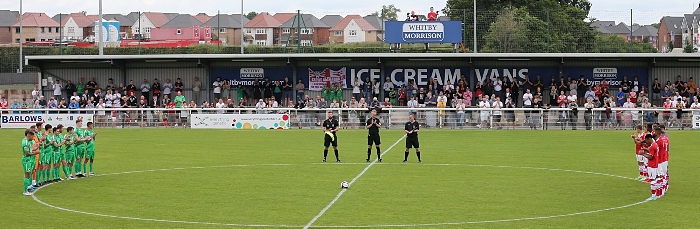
[482,10,528,53]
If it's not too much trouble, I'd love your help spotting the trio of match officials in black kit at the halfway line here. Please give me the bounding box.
[322,110,421,163]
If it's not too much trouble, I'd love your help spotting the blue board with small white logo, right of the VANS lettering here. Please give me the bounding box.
[564,68,649,90]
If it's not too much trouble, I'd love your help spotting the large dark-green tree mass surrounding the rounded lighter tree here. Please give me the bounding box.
[442,0,597,52]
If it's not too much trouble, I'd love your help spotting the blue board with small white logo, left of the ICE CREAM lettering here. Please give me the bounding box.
[209,68,292,86]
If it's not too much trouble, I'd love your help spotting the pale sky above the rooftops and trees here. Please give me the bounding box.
[0,0,700,24]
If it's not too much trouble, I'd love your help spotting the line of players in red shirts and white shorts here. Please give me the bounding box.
[632,123,669,201]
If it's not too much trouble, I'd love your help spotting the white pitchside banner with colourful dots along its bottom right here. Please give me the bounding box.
[190,114,289,130]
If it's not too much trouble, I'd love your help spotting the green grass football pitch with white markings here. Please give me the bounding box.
[0,129,700,228]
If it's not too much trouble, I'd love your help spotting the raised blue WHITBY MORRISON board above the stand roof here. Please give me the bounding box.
[384,21,462,44]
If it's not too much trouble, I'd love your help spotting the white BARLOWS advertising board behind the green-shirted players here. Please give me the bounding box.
[0,114,94,129]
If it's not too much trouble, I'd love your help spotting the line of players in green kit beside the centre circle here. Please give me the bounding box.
[22,120,97,196]
